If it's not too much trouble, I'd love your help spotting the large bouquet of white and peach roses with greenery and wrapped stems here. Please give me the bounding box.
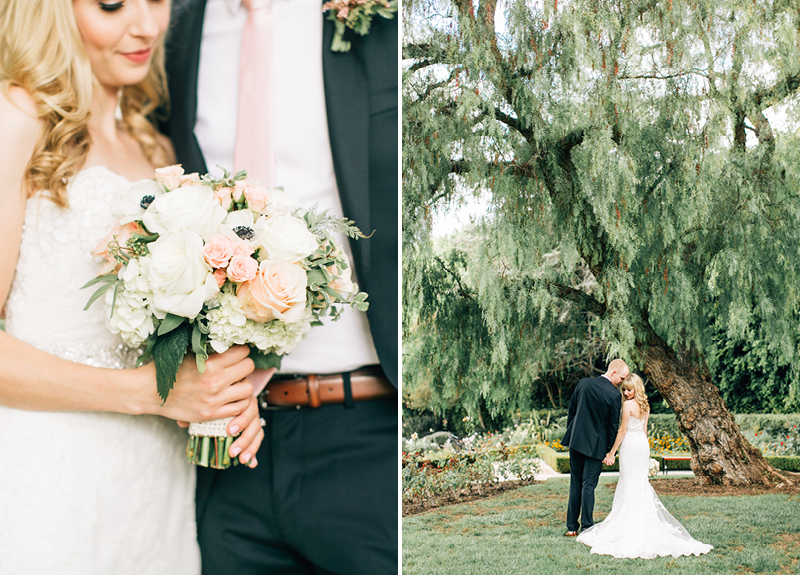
[84,165,368,469]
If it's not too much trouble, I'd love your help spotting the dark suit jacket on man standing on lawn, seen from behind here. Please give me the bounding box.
[561,377,622,459]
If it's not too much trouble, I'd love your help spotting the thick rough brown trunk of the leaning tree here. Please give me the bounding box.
[644,332,796,486]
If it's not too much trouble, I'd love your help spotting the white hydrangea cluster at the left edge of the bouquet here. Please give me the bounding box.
[105,257,155,347]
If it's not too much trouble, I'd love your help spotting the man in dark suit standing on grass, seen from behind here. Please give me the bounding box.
[562,359,629,537]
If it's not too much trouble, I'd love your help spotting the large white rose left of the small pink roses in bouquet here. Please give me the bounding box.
[148,230,219,318]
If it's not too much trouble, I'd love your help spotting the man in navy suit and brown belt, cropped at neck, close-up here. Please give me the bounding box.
[162,0,399,575]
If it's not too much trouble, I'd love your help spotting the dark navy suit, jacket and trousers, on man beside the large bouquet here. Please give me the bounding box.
[162,0,399,575]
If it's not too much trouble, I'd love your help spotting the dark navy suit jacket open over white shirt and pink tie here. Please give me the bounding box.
[161,0,399,387]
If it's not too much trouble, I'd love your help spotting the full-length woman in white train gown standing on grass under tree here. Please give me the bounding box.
[577,374,713,559]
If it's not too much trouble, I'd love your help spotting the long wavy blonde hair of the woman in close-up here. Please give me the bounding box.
[0,0,169,207]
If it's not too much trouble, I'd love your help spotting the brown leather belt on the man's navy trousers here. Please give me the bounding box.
[259,367,397,409]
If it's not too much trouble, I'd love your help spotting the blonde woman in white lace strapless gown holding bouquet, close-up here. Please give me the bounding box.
[0,0,263,575]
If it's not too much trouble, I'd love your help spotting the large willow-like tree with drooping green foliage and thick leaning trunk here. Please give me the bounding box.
[403,0,800,484]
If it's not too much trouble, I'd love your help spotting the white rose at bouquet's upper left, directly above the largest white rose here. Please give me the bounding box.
[142,186,228,239]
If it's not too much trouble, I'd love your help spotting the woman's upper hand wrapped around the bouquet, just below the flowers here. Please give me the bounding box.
[139,345,254,423]
